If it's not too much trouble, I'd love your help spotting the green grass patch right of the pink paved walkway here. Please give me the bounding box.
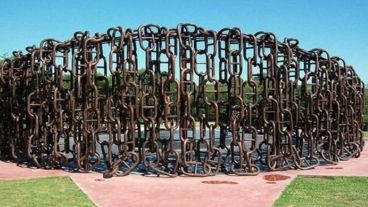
[274,176,368,207]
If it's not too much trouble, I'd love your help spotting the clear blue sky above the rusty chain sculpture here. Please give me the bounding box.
[0,0,368,83]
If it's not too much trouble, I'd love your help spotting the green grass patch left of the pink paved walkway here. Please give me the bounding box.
[0,177,95,207]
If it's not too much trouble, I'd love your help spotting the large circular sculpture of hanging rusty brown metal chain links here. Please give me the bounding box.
[0,24,364,177]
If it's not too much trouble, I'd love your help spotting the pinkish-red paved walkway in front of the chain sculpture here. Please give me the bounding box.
[0,149,368,207]
